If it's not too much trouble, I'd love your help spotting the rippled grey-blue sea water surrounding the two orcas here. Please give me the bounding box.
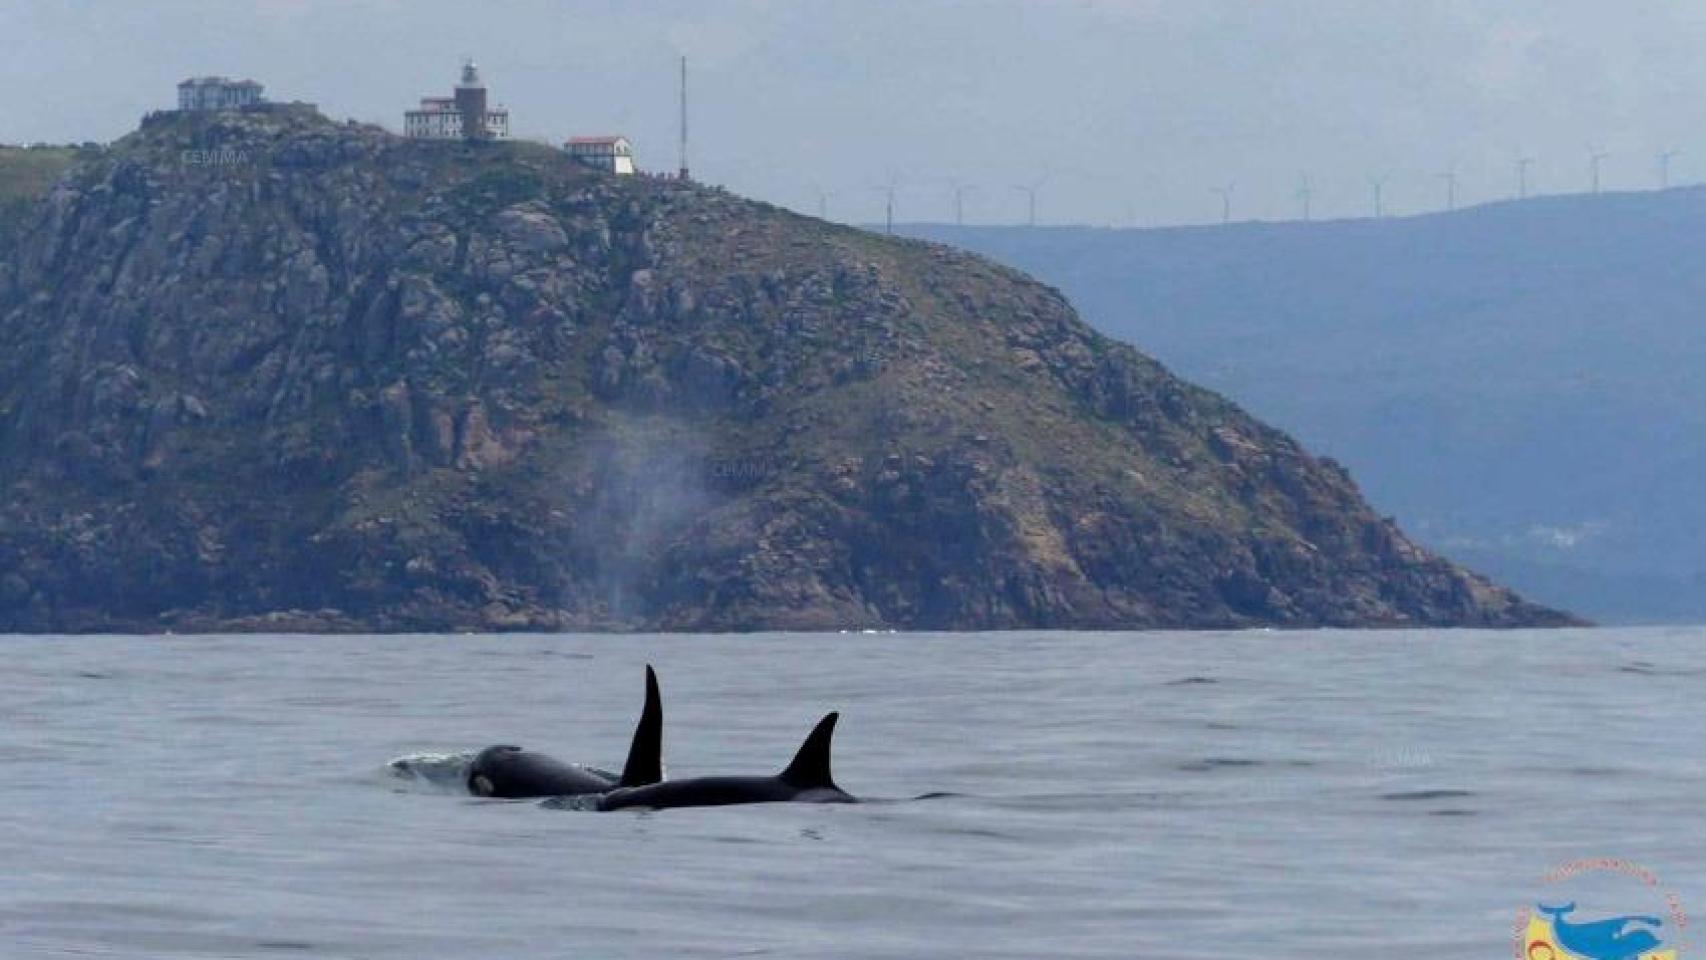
[0,629,1706,960]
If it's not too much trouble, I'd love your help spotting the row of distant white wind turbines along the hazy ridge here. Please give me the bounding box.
[829,145,1684,234]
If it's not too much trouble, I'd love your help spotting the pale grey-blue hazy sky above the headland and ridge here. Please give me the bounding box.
[0,0,1706,227]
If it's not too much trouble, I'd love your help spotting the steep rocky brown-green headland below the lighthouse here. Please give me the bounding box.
[0,107,1566,631]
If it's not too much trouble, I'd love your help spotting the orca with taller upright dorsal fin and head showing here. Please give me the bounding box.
[467,665,664,800]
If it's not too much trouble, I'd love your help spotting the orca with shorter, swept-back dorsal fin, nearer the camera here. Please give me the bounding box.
[599,713,858,810]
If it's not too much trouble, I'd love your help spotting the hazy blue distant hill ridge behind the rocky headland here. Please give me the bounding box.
[902,188,1706,622]
